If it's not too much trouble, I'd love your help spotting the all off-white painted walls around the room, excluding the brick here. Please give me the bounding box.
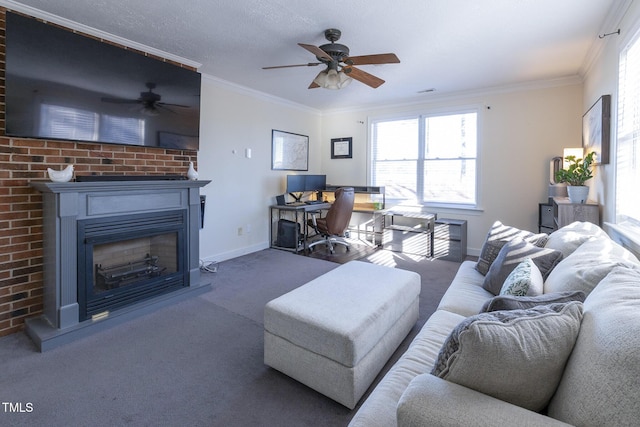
[198,2,640,261]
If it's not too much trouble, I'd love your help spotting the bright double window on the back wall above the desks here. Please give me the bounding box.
[370,110,478,206]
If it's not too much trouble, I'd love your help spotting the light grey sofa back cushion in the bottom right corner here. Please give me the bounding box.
[549,267,640,427]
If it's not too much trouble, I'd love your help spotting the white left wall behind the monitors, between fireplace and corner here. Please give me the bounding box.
[198,76,320,261]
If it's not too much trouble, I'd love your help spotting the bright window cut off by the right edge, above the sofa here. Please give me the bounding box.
[616,29,640,232]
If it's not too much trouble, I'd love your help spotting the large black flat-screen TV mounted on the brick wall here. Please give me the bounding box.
[5,12,201,150]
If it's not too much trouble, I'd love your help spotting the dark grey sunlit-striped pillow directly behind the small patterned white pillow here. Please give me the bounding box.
[482,238,562,295]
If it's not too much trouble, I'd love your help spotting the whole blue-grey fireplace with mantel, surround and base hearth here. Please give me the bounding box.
[26,180,209,351]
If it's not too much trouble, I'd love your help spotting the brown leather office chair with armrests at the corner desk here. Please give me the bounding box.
[307,187,355,253]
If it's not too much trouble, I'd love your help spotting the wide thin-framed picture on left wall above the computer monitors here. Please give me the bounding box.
[271,129,309,171]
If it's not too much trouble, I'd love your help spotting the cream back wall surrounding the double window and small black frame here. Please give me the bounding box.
[321,80,583,254]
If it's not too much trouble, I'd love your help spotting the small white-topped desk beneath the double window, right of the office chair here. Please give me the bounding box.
[380,206,436,257]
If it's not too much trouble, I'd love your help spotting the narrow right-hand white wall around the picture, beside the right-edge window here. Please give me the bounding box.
[582,1,640,226]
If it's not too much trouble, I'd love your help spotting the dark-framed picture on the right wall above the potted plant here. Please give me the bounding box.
[582,95,611,165]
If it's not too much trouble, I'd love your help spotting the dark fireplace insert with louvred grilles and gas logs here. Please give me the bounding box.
[78,210,189,321]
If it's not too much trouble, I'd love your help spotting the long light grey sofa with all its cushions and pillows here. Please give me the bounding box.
[350,222,640,427]
